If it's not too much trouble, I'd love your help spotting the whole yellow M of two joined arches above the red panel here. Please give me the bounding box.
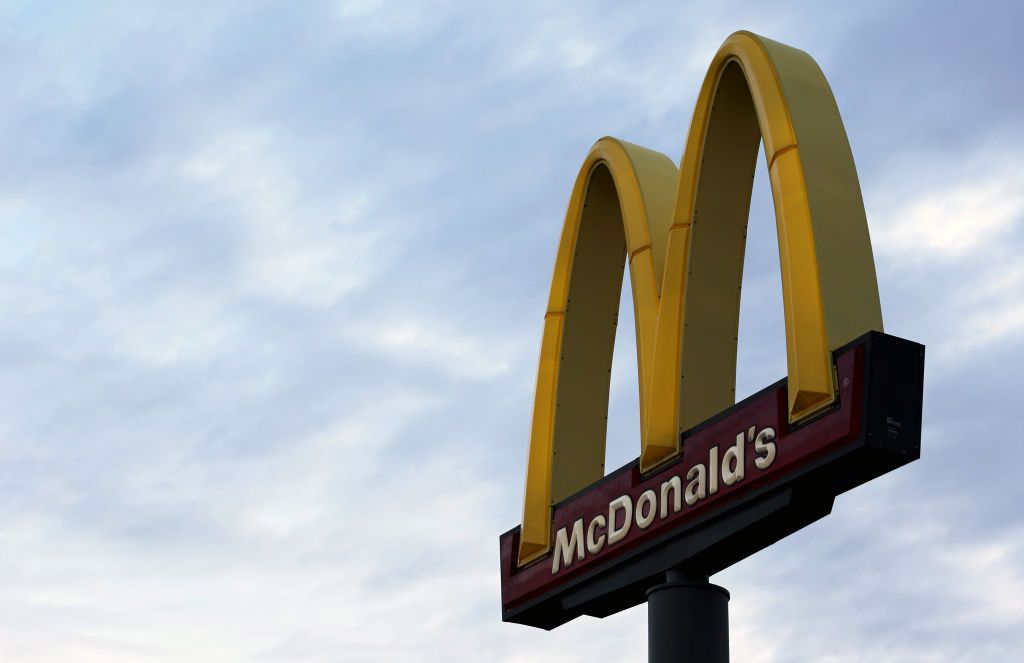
[519,32,882,565]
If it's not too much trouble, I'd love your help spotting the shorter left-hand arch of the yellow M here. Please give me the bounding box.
[519,138,677,563]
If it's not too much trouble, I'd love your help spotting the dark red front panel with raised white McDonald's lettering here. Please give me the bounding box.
[501,346,864,623]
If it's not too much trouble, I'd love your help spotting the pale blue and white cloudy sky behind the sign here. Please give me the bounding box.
[0,0,1024,663]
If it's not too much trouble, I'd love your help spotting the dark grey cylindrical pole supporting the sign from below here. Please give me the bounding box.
[647,570,729,663]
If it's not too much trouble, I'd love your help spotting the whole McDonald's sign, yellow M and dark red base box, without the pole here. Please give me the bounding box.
[500,32,924,628]
